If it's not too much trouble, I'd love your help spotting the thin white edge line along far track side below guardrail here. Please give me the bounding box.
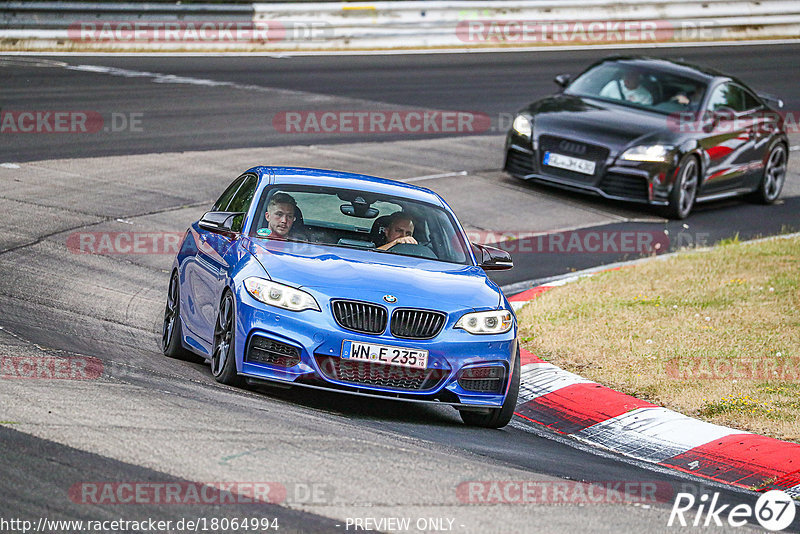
[0,39,800,59]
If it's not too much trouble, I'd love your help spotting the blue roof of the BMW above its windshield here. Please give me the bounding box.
[247,166,446,207]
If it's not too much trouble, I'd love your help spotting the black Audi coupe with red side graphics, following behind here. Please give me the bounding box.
[504,57,789,219]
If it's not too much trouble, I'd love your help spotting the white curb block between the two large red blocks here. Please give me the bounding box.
[574,408,747,463]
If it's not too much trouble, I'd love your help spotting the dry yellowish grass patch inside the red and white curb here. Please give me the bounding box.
[518,237,800,442]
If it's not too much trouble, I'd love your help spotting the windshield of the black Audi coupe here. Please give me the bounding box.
[564,61,706,114]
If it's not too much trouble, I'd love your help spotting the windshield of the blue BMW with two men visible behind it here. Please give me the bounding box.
[250,185,470,264]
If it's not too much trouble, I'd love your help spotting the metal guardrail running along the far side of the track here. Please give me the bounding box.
[0,0,800,50]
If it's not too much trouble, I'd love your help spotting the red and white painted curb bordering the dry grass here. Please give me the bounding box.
[509,267,800,498]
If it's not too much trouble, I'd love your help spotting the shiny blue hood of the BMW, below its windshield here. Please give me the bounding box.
[245,239,501,312]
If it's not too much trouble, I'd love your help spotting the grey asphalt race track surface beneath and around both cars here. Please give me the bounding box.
[0,45,800,533]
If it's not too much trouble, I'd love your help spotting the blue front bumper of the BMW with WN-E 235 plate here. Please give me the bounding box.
[231,291,517,408]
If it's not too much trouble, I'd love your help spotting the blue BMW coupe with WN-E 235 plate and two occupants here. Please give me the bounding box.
[162,167,520,428]
